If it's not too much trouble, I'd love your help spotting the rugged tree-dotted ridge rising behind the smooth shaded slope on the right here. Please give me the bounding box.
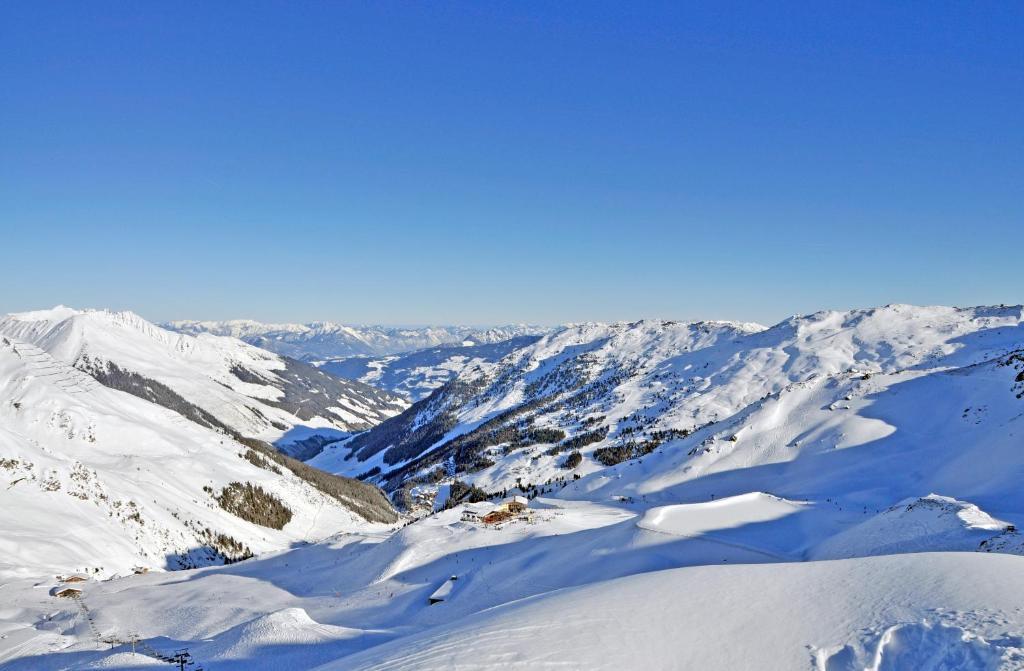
[319,305,1024,497]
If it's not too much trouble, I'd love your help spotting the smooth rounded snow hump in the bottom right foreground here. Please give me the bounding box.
[329,554,1024,671]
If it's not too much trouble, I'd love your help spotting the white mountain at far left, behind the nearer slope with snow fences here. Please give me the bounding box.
[0,306,408,452]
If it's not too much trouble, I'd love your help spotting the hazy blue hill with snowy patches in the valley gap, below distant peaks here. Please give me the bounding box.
[317,336,541,402]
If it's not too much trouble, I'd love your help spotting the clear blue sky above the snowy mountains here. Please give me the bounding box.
[0,0,1024,324]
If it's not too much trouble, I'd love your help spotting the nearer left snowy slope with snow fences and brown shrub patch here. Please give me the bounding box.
[0,336,396,580]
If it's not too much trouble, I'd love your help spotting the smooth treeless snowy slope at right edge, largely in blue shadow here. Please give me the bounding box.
[579,327,1024,523]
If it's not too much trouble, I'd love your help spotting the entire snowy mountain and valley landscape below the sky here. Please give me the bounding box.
[0,305,1024,671]
